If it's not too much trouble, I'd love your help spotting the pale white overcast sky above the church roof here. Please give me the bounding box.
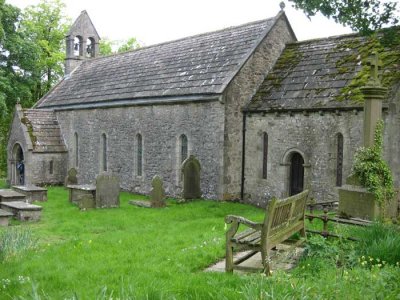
[6,0,351,46]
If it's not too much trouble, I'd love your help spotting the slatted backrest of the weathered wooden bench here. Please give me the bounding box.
[261,190,308,248]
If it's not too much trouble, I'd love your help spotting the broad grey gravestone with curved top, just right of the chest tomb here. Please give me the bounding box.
[96,172,120,208]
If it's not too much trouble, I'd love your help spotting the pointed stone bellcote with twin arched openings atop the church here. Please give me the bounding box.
[65,10,100,75]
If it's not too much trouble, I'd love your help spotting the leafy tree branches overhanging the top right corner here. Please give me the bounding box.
[289,0,399,34]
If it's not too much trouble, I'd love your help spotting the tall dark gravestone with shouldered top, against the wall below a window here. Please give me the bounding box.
[182,155,201,200]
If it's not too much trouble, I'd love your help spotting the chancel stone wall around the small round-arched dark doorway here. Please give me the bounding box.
[245,111,363,206]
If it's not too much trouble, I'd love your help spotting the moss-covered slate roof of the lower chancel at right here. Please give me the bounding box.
[245,34,400,111]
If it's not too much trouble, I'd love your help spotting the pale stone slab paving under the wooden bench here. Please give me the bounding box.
[205,244,305,273]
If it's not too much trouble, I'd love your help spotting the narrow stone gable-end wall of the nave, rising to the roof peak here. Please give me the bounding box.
[223,15,295,200]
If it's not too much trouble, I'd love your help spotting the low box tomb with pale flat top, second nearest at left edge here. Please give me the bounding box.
[0,201,42,221]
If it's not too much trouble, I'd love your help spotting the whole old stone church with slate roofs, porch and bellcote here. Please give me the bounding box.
[8,11,400,205]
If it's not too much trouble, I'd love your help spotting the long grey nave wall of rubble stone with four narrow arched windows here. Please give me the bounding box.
[57,101,224,198]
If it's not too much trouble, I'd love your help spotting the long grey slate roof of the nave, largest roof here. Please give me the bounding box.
[36,13,283,108]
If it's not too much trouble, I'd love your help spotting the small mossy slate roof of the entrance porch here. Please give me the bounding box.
[21,109,67,153]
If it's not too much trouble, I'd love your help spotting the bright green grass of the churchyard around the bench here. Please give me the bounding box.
[0,182,400,299]
